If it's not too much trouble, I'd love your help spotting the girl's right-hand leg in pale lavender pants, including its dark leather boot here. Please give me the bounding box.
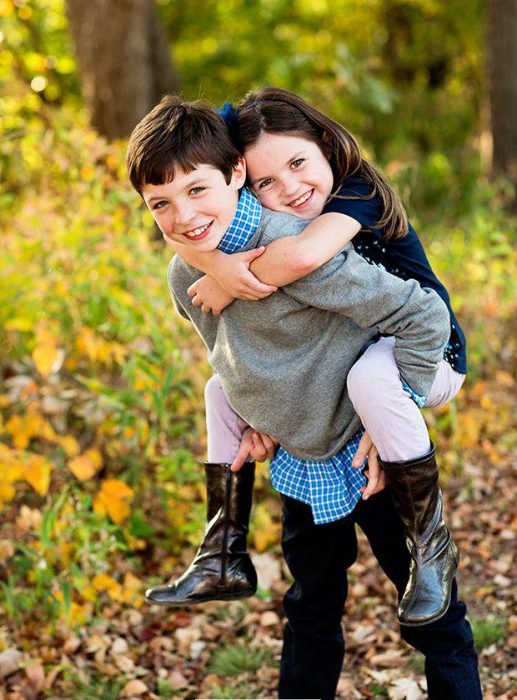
[347,338,460,626]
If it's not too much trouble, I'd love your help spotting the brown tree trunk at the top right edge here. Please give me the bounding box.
[487,0,517,183]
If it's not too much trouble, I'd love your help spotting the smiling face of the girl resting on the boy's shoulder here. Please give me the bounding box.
[244,133,334,219]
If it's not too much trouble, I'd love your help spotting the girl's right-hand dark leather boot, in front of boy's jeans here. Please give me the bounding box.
[380,446,459,627]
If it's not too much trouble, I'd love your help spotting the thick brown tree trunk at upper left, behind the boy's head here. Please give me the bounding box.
[67,0,179,139]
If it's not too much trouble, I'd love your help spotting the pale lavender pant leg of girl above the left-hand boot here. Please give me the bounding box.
[205,374,248,464]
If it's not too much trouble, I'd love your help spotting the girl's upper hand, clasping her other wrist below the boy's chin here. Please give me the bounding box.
[210,246,278,301]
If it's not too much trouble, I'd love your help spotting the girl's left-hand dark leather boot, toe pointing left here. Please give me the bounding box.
[145,462,257,607]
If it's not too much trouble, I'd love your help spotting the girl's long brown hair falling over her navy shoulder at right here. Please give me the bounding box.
[231,87,408,239]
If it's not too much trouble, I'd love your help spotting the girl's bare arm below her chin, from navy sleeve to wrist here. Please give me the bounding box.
[250,212,361,287]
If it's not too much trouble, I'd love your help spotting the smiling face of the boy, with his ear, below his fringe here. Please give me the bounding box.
[142,160,246,253]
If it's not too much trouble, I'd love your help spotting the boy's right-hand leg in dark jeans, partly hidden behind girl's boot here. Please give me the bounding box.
[355,488,482,700]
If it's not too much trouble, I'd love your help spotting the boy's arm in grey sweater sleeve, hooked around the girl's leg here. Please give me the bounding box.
[284,246,450,396]
